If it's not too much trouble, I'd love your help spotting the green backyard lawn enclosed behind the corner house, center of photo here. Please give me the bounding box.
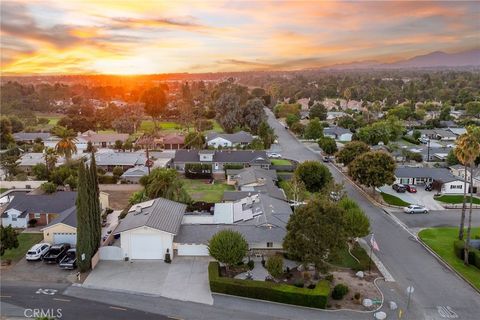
[182,179,234,203]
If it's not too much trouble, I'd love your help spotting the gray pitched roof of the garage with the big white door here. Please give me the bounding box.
[115,198,187,234]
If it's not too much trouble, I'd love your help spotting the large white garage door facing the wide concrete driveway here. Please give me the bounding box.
[130,234,164,260]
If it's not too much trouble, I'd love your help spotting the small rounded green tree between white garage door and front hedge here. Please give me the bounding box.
[208,229,248,268]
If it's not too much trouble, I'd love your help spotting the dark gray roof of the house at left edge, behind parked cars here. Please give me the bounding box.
[2,191,77,217]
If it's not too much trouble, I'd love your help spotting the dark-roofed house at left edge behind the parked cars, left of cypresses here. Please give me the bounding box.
[2,191,77,228]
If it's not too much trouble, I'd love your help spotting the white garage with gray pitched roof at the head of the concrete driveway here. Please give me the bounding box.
[114,198,187,260]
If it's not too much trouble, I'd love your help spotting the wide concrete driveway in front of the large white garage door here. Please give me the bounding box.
[83,257,213,305]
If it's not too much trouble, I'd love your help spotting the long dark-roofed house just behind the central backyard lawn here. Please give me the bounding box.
[173,150,270,173]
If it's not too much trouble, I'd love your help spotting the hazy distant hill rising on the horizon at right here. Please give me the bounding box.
[325,49,480,70]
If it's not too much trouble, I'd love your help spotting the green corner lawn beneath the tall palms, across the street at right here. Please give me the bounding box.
[418,227,480,290]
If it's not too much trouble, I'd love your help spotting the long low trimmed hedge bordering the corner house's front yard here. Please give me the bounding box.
[208,262,330,309]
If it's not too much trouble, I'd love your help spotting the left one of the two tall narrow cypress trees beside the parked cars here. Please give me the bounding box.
[76,162,92,272]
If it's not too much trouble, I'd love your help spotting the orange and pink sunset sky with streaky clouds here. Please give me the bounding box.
[1,0,480,75]
